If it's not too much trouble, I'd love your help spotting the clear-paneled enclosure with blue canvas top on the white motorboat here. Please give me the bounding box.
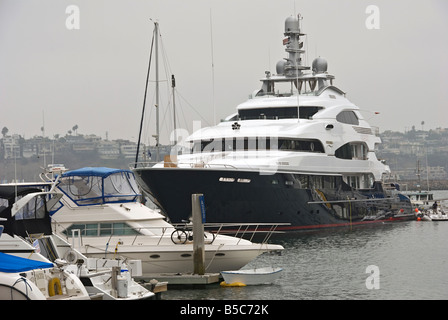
[58,170,140,205]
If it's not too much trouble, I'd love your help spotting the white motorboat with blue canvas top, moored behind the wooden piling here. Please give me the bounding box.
[1,168,283,280]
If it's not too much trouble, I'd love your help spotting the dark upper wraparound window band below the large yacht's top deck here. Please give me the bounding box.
[238,106,323,120]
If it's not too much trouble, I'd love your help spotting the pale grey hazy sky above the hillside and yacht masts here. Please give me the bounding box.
[0,0,448,144]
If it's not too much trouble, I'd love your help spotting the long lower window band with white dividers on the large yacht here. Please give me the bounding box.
[192,137,324,153]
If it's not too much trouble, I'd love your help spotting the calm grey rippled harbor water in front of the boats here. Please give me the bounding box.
[162,192,448,300]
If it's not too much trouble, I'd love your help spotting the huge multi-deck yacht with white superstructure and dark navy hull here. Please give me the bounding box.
[133,15,415,231]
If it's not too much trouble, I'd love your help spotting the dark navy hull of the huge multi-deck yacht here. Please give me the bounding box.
[134,167,415,231]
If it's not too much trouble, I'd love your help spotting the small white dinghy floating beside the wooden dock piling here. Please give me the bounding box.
[221,267,283,286]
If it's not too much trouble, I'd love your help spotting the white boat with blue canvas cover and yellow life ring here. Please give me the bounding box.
[0,187,90,300]
